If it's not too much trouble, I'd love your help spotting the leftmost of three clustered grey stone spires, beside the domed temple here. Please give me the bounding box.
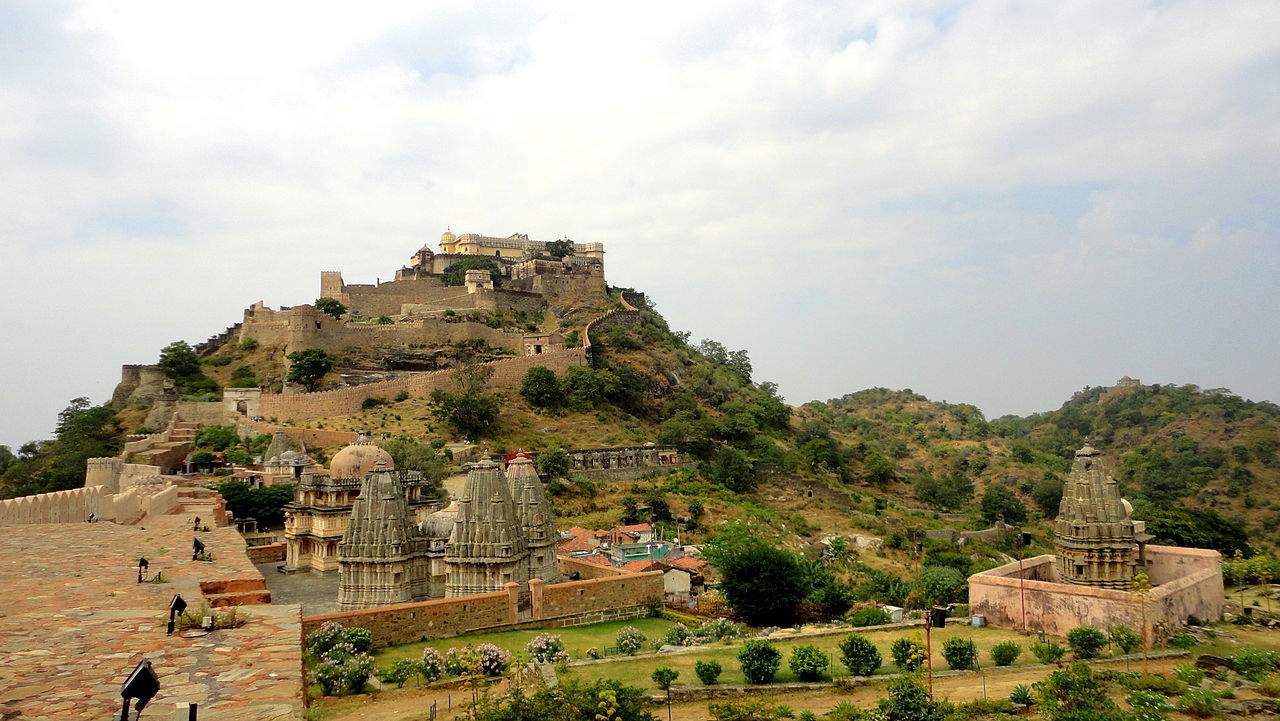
[338,464,429,611]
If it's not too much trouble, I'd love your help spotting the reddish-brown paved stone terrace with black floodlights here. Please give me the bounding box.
[0,515,302,721]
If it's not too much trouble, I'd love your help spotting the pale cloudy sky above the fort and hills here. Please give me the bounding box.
[0,0,1280,446]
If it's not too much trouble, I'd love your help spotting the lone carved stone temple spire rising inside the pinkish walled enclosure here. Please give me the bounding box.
[1053,446,1138,589]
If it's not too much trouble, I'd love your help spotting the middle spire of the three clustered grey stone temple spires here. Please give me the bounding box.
[444,458,529,597]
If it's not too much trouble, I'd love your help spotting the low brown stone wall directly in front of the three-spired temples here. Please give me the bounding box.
[302,558,662,647]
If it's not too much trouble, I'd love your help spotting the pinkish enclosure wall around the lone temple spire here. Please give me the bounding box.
[969,546,1224,636]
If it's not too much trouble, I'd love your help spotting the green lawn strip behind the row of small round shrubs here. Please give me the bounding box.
[571,626,1036,688]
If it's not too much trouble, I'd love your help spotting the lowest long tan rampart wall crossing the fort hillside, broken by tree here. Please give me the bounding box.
[261,348,586,421]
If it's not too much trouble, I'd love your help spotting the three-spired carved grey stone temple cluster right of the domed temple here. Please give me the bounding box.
[338,455,561,611]
